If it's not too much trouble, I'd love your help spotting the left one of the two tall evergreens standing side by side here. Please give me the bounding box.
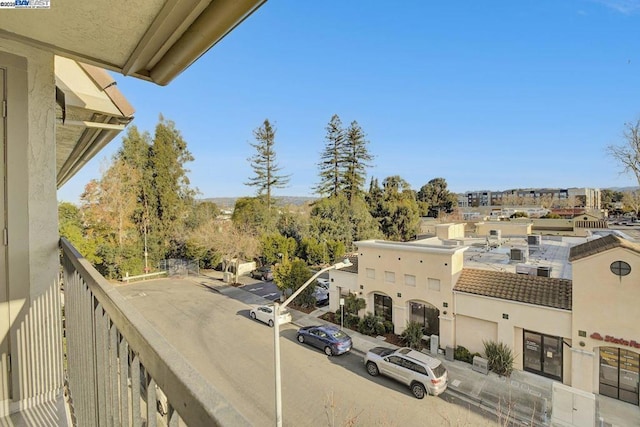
[315,114,346,197]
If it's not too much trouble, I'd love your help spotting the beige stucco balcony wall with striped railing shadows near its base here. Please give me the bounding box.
[0,40,62,412]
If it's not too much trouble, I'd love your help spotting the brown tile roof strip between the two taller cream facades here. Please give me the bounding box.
[453,268,572,310]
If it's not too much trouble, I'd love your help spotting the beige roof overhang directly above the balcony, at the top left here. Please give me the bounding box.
[0,0,266,85]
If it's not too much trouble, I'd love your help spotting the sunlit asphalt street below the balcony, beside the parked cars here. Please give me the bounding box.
[118,279,496,426]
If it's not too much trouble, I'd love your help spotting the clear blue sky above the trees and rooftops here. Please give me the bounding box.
[58,0,640,202]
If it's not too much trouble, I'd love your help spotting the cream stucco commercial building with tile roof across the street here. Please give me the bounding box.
[330,223,640,405]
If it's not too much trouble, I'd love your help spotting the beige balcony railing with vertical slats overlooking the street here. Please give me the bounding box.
[60,239,249,426]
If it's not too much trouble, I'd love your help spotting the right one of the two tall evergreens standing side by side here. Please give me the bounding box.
[342,120,373,204]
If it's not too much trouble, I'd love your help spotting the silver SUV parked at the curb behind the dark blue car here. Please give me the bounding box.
[364,347,447,399]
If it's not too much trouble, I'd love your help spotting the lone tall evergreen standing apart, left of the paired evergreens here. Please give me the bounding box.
[245,119,290,211]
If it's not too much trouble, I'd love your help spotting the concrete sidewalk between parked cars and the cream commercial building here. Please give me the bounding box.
[199,275,640,427]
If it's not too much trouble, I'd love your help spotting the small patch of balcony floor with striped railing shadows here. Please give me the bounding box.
[0,393,72,427]
